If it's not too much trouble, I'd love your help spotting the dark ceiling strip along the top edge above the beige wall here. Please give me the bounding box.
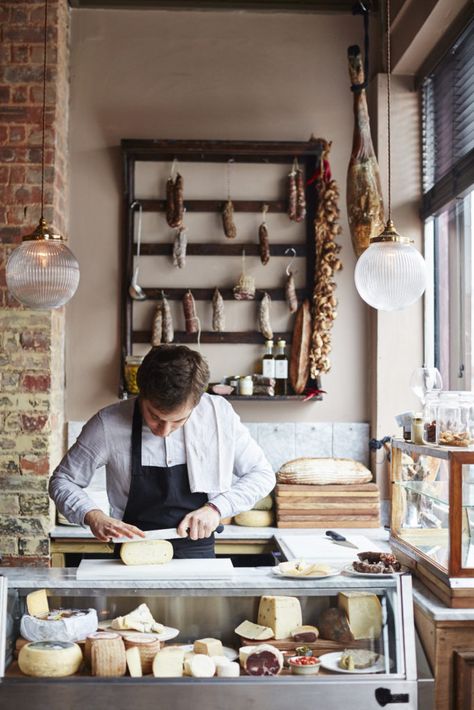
[69,0,378,13]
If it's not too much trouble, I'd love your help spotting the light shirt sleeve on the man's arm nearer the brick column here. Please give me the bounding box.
[49,412,108,525]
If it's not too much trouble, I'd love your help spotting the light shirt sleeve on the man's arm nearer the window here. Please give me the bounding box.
[209,414,275,518]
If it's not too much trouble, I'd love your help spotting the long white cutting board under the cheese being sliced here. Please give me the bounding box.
[76,557,234,582]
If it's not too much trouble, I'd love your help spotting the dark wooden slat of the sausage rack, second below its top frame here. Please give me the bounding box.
[137,242,307,259]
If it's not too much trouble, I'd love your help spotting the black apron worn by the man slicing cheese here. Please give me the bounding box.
[123,399,215,559]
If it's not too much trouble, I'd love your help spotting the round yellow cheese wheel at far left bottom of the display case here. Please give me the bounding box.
[18,641,82,678]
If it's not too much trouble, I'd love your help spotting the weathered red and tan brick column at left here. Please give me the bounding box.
[0,0,69,566]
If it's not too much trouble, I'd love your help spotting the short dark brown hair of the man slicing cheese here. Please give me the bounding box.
[137,345,209,412]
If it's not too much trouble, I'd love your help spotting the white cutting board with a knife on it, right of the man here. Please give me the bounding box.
[279,533,382,560]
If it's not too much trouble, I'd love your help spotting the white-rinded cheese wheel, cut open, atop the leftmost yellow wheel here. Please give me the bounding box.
[20,609,99,643]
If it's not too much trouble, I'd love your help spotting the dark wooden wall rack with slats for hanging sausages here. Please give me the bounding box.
[120,139,323,399]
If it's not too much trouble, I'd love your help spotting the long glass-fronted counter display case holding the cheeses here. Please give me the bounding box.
[0,568,428,710]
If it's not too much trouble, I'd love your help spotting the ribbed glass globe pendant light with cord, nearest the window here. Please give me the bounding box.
[354,0,426,311]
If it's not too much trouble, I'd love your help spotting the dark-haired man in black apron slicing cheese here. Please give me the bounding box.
[49,345,275,558]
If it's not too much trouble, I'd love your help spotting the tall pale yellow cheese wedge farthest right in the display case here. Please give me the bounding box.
[338,592,382,641]
